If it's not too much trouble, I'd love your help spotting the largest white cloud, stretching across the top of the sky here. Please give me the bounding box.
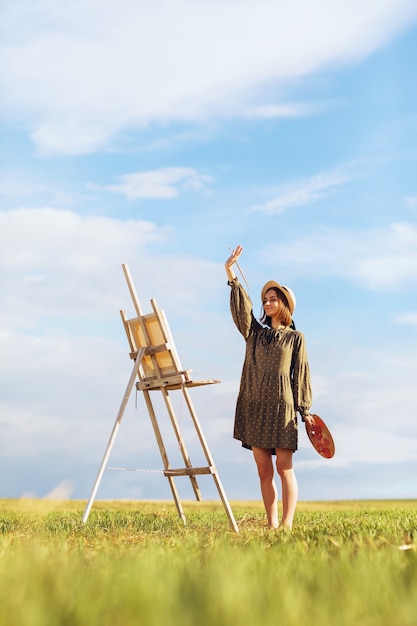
[1,0,417,154]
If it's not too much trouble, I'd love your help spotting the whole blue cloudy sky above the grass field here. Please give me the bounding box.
[0,0,417,508]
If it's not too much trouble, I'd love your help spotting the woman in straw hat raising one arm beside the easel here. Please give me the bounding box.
[225,246,314,530]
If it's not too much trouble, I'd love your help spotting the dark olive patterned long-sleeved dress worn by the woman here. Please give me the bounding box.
[228,278,312,451]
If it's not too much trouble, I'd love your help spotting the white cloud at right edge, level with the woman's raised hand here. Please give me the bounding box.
[262,222,417,290]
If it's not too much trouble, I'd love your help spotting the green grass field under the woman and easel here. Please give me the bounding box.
[0,500,417,626]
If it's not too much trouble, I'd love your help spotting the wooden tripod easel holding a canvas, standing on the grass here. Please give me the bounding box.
[82,264,239,532]
